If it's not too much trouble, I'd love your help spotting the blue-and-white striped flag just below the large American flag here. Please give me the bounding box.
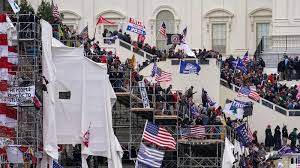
[136,143,165,168]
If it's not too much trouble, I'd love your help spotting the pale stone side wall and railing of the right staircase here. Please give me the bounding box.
[220,79,300,142]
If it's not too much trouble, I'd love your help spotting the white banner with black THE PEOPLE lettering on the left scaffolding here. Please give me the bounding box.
[0,86,35,105]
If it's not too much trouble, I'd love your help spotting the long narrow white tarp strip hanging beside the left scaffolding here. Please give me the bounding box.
[41,20,58,161]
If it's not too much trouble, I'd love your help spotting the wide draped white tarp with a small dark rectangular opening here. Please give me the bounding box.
[42,19,123,168]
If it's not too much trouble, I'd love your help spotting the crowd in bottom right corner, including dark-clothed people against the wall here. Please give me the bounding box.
[226,117,300,168]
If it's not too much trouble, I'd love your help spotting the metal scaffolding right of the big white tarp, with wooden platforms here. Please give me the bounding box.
[110,71,226,168]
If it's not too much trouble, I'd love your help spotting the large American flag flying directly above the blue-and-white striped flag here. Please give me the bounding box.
[143,121,176,150]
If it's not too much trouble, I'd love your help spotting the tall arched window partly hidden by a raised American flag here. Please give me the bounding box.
[156,10,175,49]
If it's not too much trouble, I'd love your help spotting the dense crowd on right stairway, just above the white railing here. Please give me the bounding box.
[221,56,300,109]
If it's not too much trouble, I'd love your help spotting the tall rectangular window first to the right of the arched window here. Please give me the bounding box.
[212,23,226,53]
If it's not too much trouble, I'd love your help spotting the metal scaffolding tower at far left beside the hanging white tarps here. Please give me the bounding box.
[1,14,43,167]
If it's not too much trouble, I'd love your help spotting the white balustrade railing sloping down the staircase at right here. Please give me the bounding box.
[220,78,300,117]
